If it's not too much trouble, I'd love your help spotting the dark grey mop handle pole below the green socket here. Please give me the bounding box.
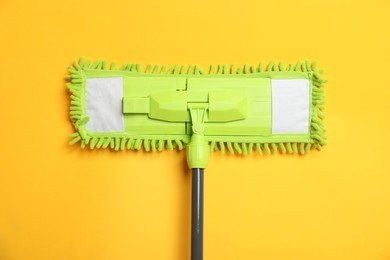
[191,168,204,260]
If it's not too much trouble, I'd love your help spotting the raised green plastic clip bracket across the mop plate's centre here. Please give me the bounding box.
[123,90,248,122]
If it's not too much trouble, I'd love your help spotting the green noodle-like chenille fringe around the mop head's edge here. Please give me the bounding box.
[66,58,327,155]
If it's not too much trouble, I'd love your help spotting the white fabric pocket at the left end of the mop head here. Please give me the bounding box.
[85,77,125,132]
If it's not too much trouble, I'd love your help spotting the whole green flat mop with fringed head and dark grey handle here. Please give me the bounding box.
[67,58,326,260]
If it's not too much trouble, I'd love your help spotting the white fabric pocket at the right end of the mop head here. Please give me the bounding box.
[271,79,310,134]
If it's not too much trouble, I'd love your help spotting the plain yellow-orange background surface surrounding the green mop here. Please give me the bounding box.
[0,0,390,260]
